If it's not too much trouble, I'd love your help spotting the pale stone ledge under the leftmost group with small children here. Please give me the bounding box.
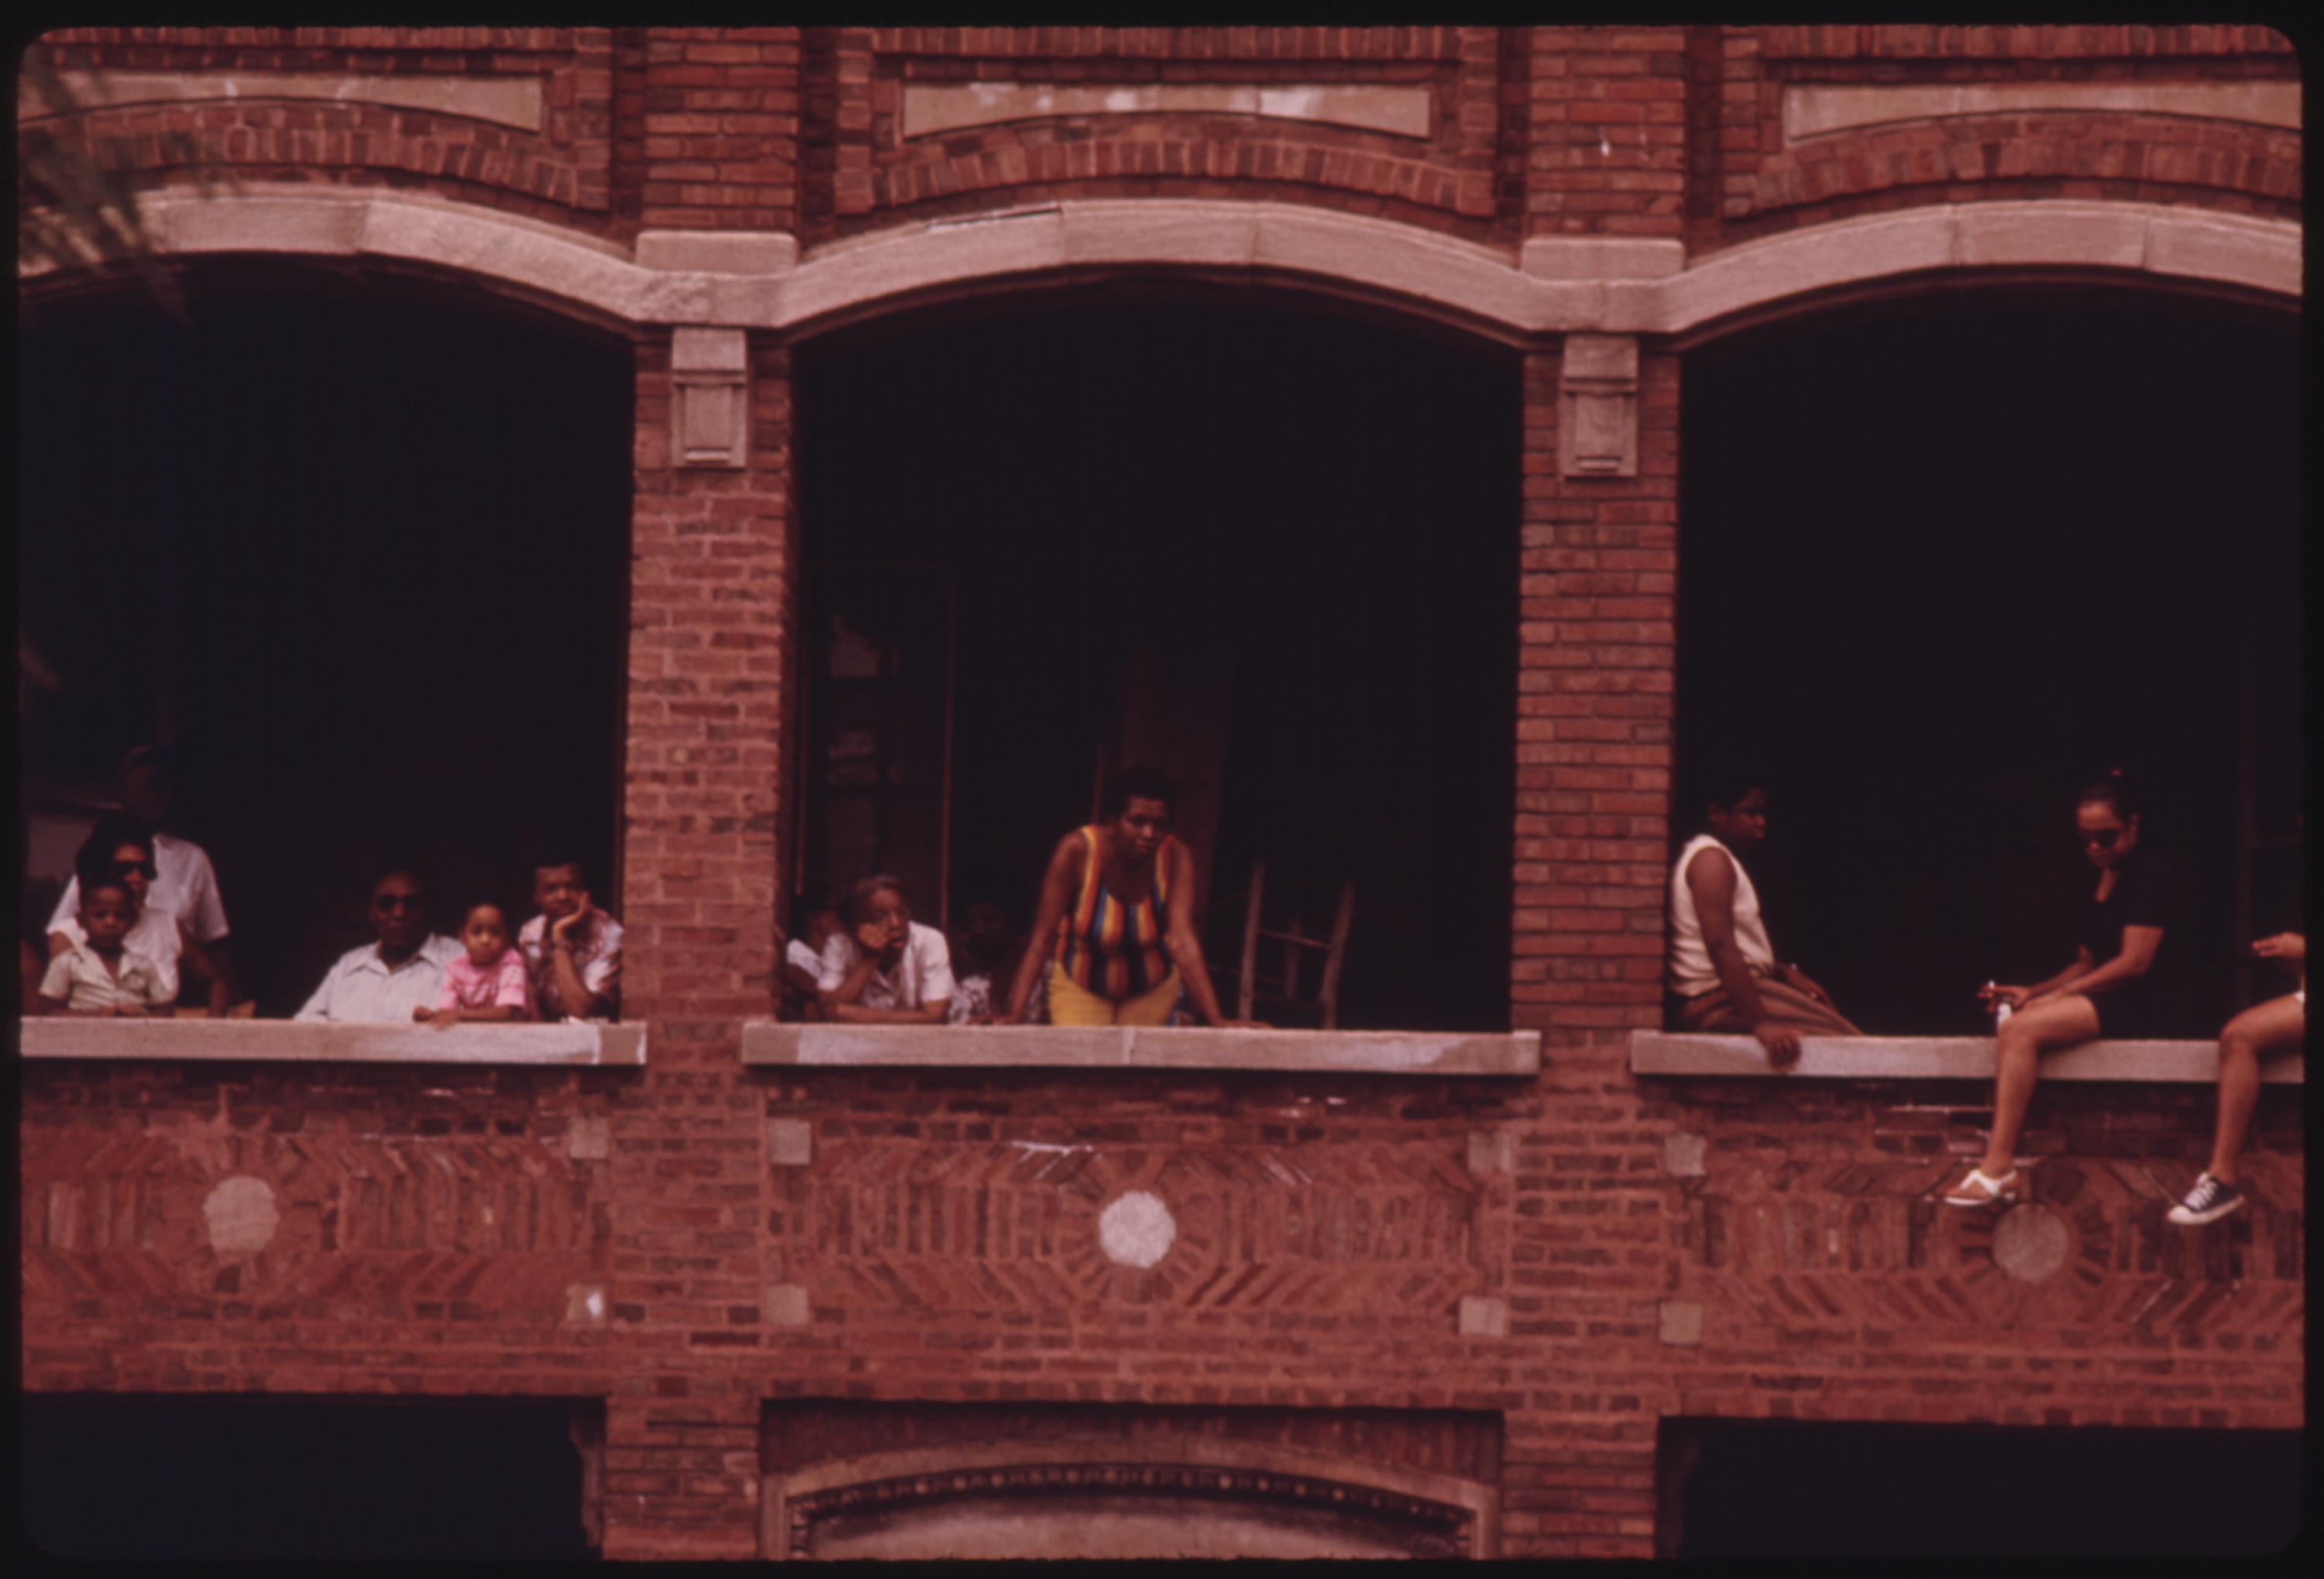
[16,1014,646,1065]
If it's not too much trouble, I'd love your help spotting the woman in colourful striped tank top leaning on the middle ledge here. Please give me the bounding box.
[999,767,1257,1028]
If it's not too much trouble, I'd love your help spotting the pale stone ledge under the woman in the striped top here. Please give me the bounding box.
[741,1021,1541,1075]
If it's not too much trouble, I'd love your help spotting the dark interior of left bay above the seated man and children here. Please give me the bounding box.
[19,270,632,1014]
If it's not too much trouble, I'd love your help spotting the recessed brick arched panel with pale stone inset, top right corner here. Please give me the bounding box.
[1687,26,2301,251]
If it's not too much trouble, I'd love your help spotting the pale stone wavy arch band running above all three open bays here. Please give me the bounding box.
[28,186,2301,344]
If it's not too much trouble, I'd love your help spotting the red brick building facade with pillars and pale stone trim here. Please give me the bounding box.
[19,26,2303,1558]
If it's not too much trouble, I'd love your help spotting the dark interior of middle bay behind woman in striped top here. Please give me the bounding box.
[797,291,1518,1028]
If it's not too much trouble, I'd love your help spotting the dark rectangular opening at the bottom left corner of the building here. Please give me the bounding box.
[19,1393,604,1560]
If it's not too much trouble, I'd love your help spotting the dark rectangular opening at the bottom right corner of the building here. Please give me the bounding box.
[1657,1419,2308,1558]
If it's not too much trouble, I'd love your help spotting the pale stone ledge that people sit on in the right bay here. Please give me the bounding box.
[1629,1030,2305,1086]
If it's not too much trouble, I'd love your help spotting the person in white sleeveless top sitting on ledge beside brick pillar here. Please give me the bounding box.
[1669,786,1864,1070]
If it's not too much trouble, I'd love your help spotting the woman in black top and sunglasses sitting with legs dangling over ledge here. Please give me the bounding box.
[1945,767,2171,1207]
